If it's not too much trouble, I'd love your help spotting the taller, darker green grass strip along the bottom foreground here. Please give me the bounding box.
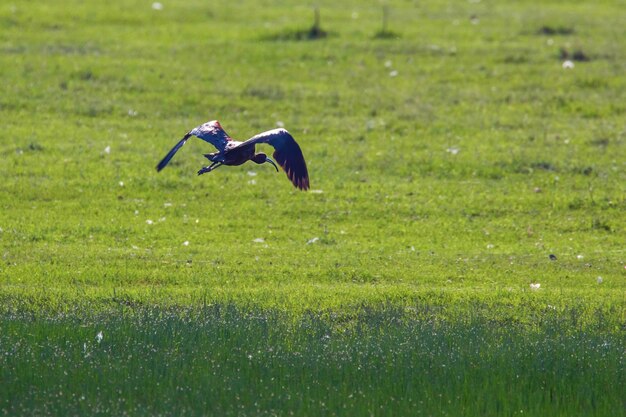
[0,306,625,416]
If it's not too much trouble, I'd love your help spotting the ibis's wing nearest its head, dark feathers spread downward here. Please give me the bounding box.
[239,129,309,190]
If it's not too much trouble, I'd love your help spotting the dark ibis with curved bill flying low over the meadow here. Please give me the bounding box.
[157,120,309,191]
